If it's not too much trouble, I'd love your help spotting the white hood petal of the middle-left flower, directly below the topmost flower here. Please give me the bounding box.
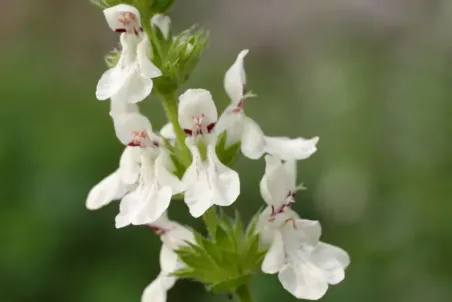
[114,113,152,145]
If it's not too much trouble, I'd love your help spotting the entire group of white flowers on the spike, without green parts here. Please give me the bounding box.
[86,4,349,302]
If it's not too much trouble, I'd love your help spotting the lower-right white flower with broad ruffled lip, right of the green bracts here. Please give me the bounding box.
[257,155,350,300]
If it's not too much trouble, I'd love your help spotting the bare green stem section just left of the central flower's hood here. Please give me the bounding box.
[160,94,191,167]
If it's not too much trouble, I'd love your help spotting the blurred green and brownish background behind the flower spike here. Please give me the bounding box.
[0,0,452,302]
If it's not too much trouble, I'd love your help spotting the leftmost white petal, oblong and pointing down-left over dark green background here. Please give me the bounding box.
[86,171,127,210]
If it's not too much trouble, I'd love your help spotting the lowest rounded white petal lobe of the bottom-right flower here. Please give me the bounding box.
[278,261,328,300]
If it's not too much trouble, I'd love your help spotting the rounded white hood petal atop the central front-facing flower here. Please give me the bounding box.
[178,89,218,129]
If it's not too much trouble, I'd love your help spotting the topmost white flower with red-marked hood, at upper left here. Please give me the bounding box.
[96,4,162,104]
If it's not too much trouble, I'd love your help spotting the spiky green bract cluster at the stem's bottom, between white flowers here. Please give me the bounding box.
[174,208,266,292]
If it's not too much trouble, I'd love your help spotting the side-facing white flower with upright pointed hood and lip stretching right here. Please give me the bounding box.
[217,50,319,160]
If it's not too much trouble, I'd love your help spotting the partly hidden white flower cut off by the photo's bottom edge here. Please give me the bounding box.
[141,214,195,302]
